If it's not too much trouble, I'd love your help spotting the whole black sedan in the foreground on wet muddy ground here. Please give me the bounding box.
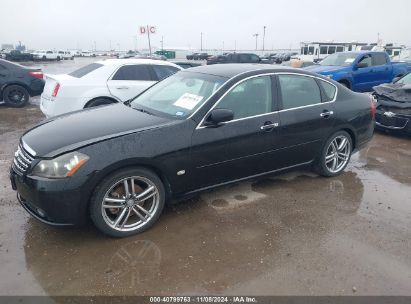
[10,64,375,237]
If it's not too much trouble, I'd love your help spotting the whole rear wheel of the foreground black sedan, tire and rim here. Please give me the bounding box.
[317,131,352,176]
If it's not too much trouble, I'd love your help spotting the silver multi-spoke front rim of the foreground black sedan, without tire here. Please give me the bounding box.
[101,176,160,231]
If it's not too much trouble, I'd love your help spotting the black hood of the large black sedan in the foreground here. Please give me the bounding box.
[22,103,175,157]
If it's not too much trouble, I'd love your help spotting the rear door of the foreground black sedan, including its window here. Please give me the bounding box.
[278,74,336,167]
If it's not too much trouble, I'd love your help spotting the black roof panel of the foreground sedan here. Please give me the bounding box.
[185,63,295,78]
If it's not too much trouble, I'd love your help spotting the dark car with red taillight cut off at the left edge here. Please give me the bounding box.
[0,59,44,107]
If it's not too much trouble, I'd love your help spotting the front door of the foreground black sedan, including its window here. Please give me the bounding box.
[191,76,279,188]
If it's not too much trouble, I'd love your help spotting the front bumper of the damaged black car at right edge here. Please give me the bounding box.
[375,110,411,134]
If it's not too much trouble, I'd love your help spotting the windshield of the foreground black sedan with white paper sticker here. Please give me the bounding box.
[131,72,227,119]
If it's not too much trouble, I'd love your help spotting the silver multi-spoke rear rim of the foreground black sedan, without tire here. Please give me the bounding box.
[325,135,351,173]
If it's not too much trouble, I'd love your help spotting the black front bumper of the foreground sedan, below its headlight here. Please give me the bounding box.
[10,169,89,226]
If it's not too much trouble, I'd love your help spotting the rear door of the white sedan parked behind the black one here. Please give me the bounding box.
[107,64,156,101]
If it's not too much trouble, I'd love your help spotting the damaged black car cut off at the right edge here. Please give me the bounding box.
[373,73,411,134]
